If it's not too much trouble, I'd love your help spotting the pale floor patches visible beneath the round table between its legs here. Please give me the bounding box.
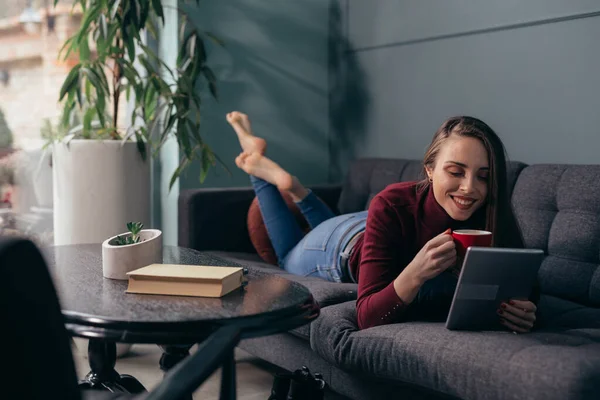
[73,339,273,400]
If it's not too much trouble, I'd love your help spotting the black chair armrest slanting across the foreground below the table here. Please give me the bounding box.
[140,326,240,400]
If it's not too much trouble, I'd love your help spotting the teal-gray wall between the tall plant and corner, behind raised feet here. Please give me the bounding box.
[180,0,329,190]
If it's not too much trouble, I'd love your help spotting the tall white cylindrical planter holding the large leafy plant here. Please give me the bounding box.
[52,140,151,245]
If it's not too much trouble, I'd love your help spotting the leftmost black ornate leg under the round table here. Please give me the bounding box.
[79,339,146,394]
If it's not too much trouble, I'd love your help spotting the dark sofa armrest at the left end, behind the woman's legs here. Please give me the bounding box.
[178,185,341,253]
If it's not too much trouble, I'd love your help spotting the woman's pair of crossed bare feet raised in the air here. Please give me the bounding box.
[227,111,308,201]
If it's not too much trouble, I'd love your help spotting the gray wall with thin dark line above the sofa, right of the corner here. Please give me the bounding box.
[330,0,600,179]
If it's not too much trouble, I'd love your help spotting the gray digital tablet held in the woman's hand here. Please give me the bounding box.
[446,247,544,330]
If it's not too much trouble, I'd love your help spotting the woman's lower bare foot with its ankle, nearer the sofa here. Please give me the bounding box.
[235,152,308,202]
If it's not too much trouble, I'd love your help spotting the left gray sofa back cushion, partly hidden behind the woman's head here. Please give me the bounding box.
[338,158,526,214]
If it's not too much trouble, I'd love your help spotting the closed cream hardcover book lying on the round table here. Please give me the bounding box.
[127,264,244,297]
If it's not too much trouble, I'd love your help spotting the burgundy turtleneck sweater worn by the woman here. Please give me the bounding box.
[349,182,485,329]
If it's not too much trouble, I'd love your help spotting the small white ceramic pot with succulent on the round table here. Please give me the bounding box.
[102,229,162,280]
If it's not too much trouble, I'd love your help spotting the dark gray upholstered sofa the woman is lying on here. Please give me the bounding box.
[179,159,600,400]
